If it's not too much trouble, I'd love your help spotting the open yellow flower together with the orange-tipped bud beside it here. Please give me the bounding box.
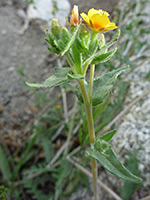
[70,5,118,32]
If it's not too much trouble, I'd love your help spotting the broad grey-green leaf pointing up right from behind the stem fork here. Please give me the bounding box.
[92,66,129,106]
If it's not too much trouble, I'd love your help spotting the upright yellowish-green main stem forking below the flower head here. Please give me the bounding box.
[78,65,98,200]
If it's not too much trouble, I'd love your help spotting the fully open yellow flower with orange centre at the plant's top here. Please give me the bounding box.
[81,8,117,32]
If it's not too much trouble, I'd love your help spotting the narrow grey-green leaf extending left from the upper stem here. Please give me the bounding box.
[26,67,71,88]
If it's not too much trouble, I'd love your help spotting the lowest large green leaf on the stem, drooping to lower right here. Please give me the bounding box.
[86,138,142,183]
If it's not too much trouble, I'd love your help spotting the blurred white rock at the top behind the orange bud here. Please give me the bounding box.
[27,0,71,26]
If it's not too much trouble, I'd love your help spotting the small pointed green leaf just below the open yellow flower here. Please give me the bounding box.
[92,48,117,64]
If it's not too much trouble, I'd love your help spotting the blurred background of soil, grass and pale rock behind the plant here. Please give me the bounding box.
[0,0,150,200]
